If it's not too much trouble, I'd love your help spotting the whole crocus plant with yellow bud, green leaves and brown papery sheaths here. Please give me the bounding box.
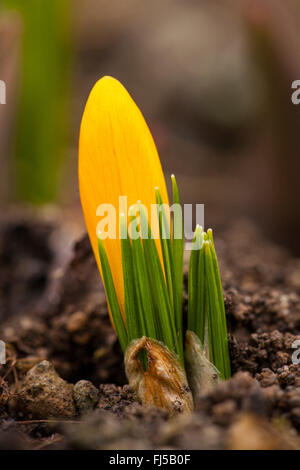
[79,77,230,413]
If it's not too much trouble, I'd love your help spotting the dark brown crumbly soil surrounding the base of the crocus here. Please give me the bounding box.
[0,213,300,449]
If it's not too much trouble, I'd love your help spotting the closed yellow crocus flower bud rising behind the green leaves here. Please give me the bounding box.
[79,77,168,317]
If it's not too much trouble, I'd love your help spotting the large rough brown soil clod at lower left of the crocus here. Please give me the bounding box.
[9,361,75,419]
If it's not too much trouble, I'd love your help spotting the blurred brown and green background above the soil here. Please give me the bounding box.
[0,0,300,254]
